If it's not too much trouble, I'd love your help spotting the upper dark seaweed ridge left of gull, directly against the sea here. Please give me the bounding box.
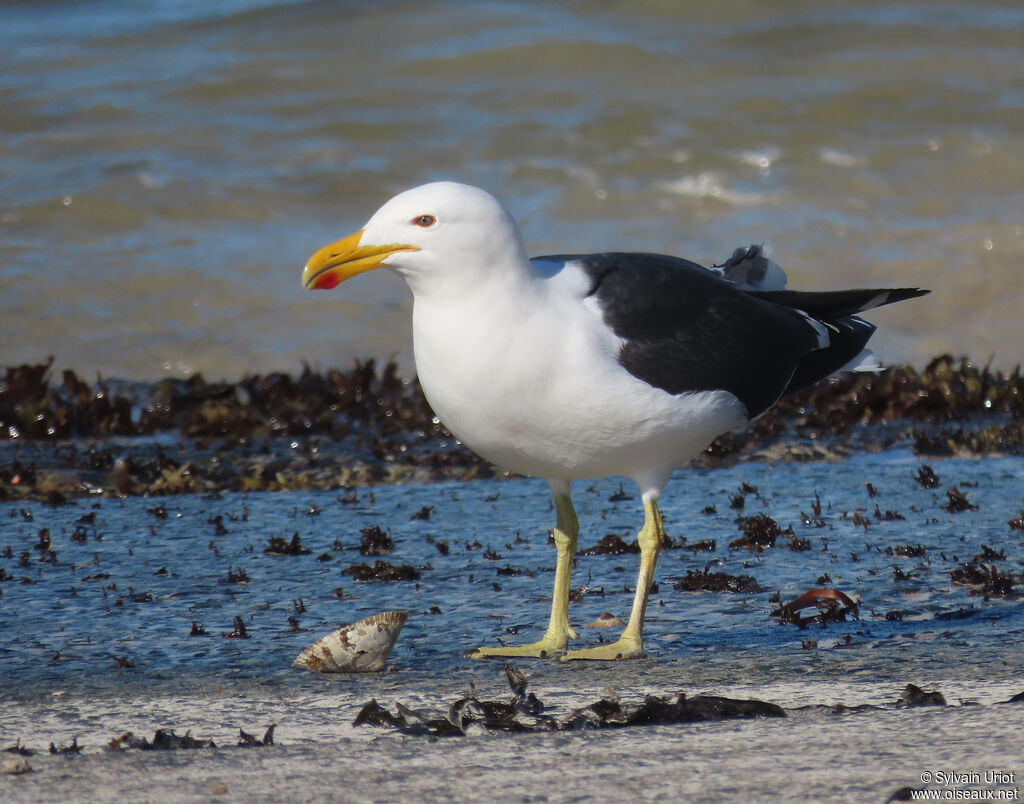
[0,357,439,440]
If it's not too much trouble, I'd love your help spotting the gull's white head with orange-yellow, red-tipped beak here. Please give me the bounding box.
[302,181,527,294]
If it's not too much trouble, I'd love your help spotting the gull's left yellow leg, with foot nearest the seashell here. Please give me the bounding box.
[469,484,580,659]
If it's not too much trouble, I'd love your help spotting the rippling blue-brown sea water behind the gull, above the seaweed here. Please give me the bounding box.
[0,0,1024,379]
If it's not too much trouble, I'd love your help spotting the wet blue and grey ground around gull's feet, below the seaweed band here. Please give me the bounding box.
[0,451,1024,801]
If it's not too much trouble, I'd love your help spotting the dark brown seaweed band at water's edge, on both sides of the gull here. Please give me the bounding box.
[0,355,1024,497]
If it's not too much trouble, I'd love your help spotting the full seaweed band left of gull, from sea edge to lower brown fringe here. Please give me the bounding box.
[0,359,494,495]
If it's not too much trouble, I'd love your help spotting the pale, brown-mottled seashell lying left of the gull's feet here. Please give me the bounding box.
[292,611,409,673]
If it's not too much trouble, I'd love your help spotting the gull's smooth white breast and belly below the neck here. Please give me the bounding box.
[414,284,745,493]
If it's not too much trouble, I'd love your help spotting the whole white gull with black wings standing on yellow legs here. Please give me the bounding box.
[302,181,928,660]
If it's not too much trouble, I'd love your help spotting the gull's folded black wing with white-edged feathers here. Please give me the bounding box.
[539,253,923,418]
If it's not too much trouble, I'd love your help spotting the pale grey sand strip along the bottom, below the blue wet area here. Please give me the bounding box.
[6,669,1024,802]
